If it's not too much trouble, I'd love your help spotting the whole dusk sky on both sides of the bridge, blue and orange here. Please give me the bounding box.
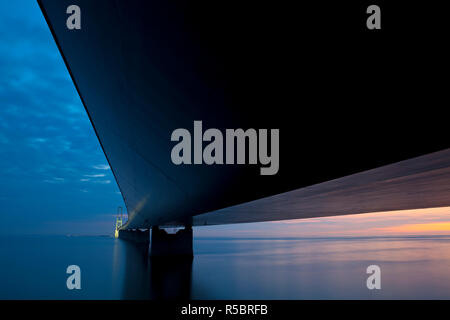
[0,0,450,237]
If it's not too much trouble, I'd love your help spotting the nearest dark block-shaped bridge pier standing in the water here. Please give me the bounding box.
[150,226,194,258]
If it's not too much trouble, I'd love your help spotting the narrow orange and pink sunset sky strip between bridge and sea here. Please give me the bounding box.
[196,207,450,237]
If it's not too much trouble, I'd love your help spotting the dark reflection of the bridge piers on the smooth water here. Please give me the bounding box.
[113,239,193,300]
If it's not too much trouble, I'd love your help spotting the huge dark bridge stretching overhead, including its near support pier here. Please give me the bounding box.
[38,0,450,255]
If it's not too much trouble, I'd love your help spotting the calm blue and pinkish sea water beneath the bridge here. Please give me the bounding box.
[0,236,450,299]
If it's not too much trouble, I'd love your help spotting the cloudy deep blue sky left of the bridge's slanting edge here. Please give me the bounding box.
[0,0,124,234]
